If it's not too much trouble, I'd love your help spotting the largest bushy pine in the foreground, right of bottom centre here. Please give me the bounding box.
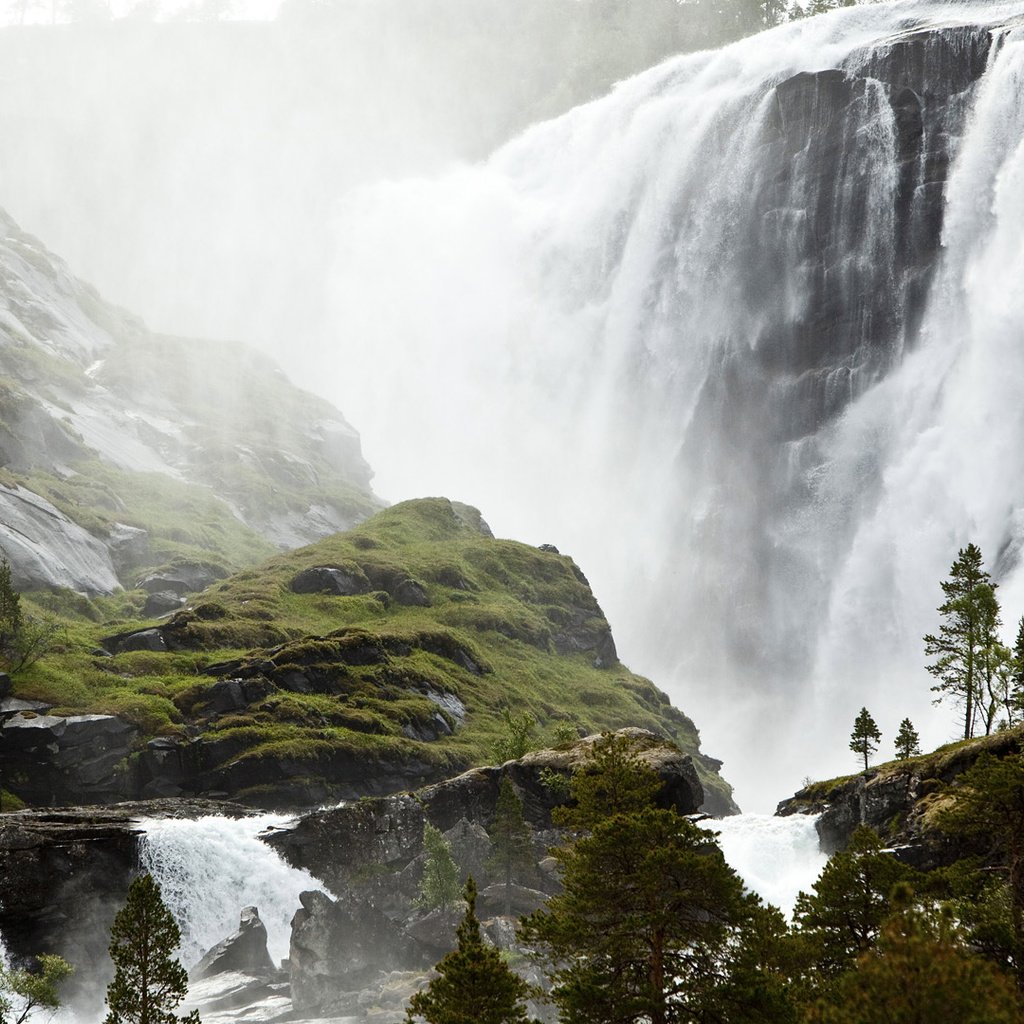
[520,739,751,1024]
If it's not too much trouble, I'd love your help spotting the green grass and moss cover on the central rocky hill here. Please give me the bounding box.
[17,499,728,811]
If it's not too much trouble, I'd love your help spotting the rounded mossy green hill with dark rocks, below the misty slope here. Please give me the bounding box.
[9,499,732,811]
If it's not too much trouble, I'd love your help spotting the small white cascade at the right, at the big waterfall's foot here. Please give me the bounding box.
[701,814,828,918]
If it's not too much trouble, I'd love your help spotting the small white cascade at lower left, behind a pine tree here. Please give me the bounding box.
[139,814,324,968]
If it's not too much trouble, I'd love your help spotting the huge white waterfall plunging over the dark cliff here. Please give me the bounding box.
[321,0,1024,807]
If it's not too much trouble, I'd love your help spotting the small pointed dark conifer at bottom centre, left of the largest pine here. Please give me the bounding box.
[406,878,529,1024]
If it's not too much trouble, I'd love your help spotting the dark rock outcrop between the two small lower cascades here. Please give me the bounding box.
[264,729,703,1020]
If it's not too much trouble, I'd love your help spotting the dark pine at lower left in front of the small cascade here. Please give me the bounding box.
[103,874,200,1024]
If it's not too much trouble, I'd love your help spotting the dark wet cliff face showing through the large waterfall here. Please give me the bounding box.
[667,27,993,680]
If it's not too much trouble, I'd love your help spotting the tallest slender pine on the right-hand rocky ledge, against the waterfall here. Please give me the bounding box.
[925,544,998,739]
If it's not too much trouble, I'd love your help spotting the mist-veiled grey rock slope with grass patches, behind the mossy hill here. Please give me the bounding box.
[0,206,380,594]
